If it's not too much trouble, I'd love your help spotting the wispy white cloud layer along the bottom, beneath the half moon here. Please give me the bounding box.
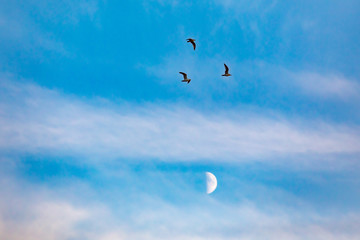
[0,167,360,240]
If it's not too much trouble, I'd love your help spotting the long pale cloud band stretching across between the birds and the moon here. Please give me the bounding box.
[0,78,360,161]
